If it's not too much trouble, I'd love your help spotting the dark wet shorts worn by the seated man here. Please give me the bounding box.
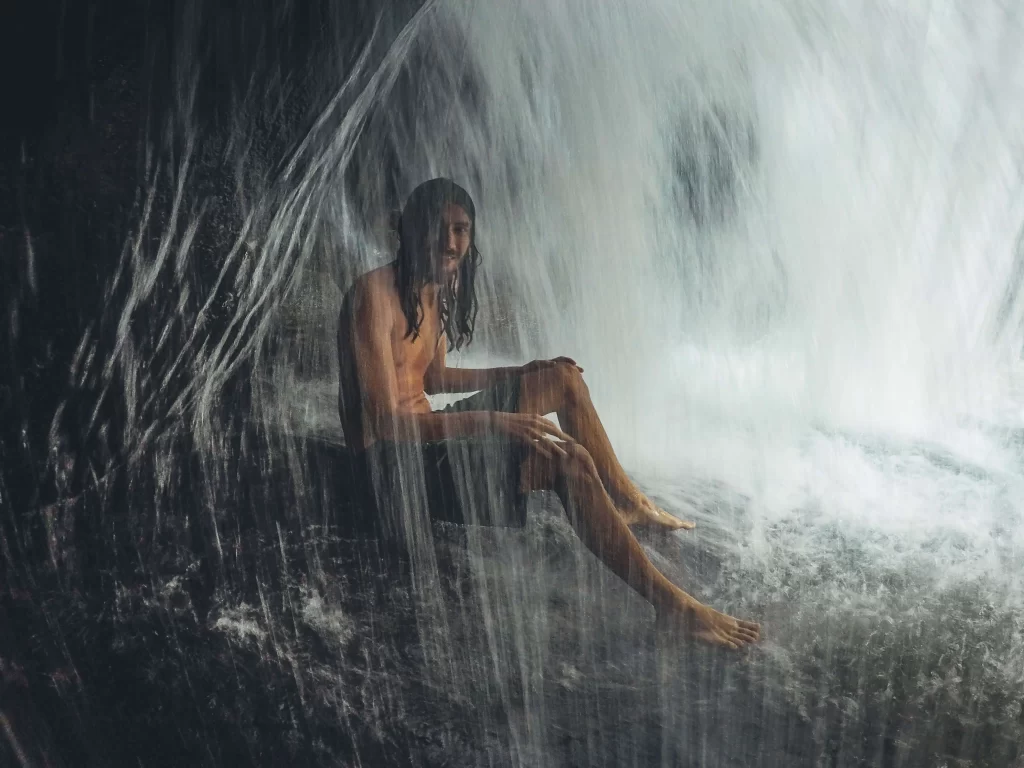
[355,377,526,528]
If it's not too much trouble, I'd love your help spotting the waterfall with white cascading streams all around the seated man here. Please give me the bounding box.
[8,0,1024,766]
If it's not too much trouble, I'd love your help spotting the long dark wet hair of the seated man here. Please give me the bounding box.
[395,178,480,350]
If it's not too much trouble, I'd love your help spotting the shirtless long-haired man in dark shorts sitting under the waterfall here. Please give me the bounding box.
[338,179,760,648]
